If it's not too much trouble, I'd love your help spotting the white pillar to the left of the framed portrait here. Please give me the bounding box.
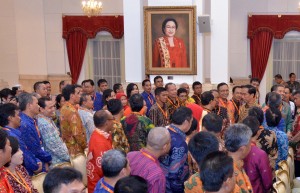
[123,0,145,82]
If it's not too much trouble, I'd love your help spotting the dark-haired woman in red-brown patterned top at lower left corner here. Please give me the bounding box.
[5,136,38,193]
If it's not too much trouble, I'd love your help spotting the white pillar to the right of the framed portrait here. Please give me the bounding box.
[210,0,230,84]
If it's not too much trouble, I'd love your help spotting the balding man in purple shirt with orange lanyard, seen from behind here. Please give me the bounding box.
[127,127,171,193]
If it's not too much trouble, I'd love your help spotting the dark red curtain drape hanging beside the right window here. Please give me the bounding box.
[250,31,273,80]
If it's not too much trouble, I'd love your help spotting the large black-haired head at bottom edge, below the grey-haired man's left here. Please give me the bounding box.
[200,151,235,193]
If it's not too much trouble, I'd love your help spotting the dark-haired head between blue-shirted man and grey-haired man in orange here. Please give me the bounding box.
[188,131,219,167]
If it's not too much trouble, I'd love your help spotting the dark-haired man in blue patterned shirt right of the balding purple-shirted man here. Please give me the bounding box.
[160,107,193,193]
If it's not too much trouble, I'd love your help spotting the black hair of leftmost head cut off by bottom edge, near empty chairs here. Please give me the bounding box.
[43,167,82,193]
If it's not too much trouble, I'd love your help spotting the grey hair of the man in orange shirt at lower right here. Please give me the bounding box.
[225,123,252,152]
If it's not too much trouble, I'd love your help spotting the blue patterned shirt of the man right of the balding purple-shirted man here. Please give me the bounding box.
[160,124,189,193]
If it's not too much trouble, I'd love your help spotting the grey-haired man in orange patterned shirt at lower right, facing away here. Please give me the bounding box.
[225,124,253,193]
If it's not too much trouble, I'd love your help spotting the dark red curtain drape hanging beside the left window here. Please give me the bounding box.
[66,31,88,84]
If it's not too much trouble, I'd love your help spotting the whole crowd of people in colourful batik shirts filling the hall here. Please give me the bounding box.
[0,73,300,193]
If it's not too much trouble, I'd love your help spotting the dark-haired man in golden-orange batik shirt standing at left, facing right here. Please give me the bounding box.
[59,85,87,156]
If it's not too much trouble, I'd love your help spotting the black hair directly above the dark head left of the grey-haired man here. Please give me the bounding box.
[202,113,223,133]
